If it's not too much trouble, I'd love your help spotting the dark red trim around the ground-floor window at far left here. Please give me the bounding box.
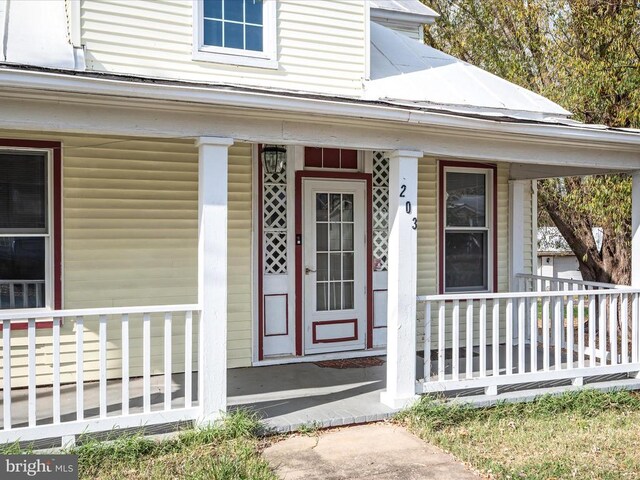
[0,138,62,330]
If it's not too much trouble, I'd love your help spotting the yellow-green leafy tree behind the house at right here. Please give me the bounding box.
[425,0,640,283]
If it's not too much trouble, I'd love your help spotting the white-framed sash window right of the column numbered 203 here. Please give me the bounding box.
[441,166,495,293]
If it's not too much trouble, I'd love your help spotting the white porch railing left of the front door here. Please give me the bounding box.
[0,305,200,444]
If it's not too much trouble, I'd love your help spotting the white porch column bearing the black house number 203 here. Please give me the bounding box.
[380,150,422,408]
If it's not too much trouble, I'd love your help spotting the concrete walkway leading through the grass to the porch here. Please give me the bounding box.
[264,423,480,480]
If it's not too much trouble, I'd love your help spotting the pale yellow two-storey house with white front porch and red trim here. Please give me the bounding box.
[0,0,640,440]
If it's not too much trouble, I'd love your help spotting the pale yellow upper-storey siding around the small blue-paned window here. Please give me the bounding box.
[81,0,366,95]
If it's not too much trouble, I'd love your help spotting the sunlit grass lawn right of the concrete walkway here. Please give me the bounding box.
[397,390,640,479]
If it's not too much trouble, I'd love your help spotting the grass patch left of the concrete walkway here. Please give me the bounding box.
[0,412,277,480]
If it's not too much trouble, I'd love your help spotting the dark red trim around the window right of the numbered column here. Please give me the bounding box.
[438,160,498,294]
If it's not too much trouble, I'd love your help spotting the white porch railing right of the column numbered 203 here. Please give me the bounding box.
[417,276,640,394]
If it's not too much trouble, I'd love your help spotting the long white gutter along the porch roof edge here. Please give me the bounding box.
[0,68,640,153]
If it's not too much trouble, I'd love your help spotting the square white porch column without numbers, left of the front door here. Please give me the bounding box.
[196,137,233,425]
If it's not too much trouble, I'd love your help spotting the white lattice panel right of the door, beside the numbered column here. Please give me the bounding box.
[372,152,389,271]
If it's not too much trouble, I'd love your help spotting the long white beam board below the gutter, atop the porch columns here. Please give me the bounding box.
[0,94,640,173]
